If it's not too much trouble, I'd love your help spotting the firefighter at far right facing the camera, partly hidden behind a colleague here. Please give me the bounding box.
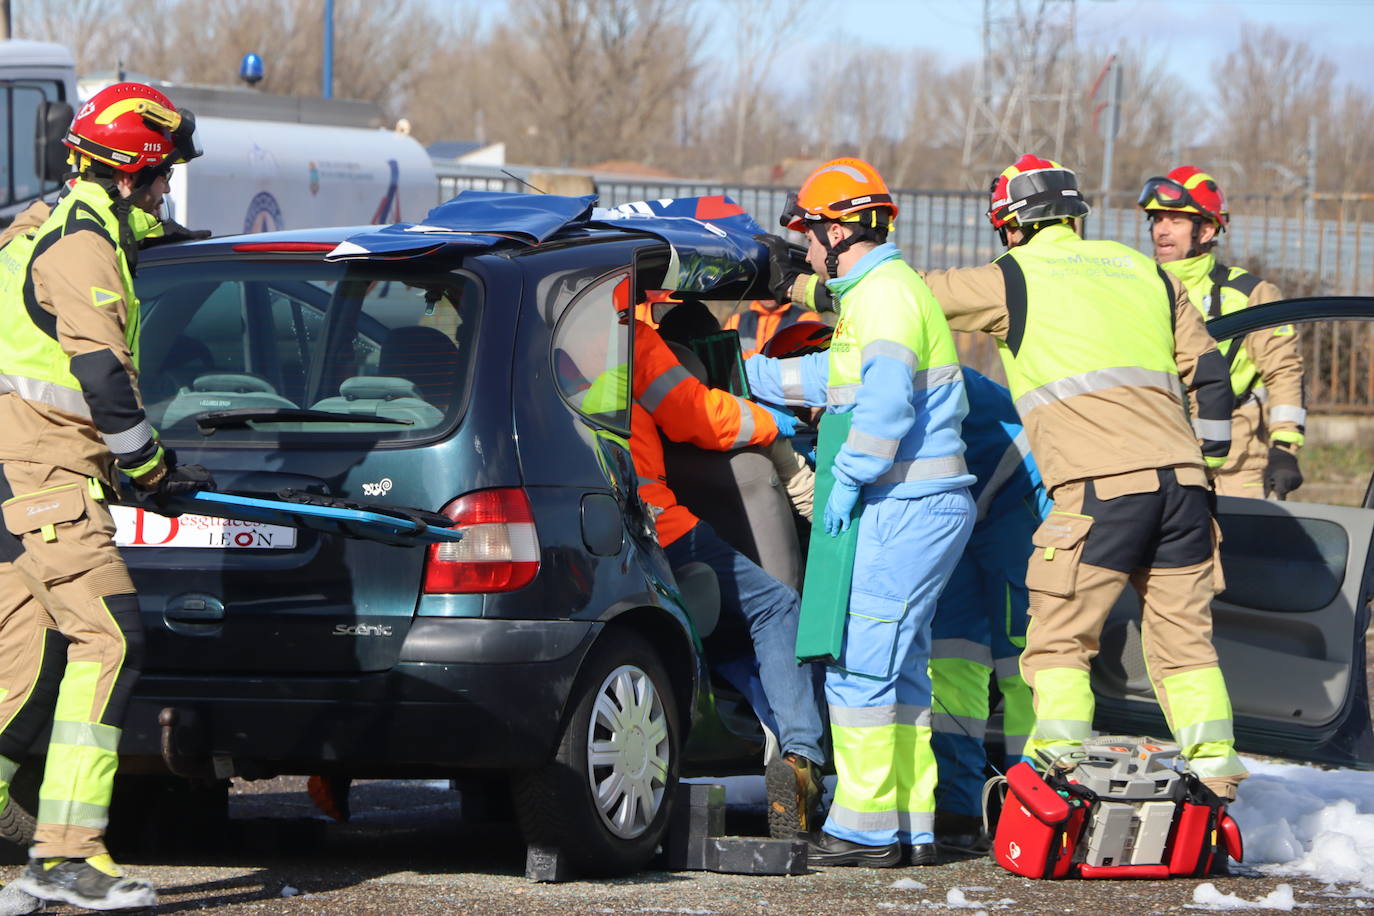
[1139,165,1307,500]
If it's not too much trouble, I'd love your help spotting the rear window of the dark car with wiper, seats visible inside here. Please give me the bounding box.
[137,260,482,444]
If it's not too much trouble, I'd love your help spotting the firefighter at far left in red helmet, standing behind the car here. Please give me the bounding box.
[0,82,213,909]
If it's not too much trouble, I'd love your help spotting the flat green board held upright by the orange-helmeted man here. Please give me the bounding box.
[797,413,863,662]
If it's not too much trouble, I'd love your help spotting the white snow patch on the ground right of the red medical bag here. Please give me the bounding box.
[1230,759,1374,890]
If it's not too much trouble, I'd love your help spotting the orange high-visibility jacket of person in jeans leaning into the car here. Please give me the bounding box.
[629,321,778,547]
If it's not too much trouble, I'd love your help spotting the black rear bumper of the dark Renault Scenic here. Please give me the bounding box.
[112,618,600,776]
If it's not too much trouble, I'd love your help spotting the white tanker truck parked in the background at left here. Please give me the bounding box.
[0,41,438,235]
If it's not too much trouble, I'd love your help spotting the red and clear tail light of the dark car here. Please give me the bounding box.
[425,489,539,595]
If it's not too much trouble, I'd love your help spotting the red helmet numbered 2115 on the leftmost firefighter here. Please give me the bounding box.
[63,82,201,173]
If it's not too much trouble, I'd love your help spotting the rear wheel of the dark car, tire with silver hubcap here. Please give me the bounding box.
[513,630,682,876]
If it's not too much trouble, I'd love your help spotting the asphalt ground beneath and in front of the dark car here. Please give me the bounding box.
[0,777,1374,916]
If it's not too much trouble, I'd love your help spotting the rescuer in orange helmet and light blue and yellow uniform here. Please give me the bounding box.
[745,158,974,868]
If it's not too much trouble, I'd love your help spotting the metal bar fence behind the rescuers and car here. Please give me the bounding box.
[436,165,1374,413]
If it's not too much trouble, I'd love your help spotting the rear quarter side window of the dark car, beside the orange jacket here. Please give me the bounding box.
[551,271,629,435]
